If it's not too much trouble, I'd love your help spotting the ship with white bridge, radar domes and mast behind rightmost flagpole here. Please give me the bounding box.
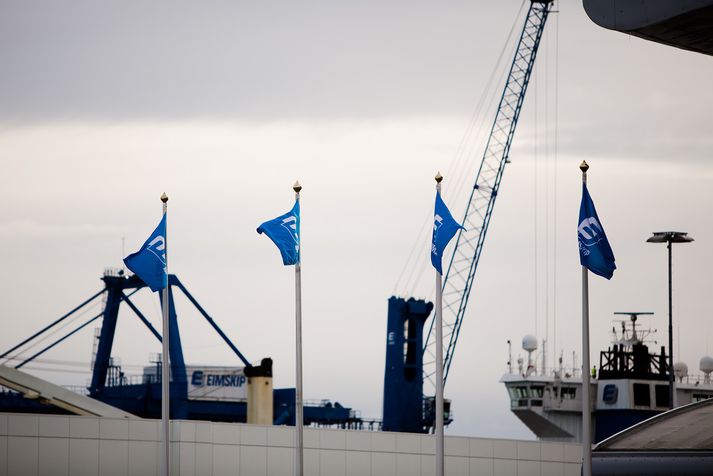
[500,312,713,442]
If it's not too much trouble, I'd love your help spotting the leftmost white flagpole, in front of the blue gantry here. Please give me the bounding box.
[161,193,171,476]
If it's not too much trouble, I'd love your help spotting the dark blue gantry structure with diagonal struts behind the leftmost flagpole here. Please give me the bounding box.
[0,271,362,427]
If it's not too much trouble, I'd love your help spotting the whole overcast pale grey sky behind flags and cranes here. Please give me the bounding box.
[0,0,713,438]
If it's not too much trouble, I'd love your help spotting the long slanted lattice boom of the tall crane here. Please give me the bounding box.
[423,0,553,394]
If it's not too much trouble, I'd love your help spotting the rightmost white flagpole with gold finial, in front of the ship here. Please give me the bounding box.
[579,161,592,476]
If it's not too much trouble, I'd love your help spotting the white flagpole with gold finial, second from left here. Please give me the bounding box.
[292,182,304,476]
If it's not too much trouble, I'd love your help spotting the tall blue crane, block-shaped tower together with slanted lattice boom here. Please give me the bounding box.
[383,0,553,431]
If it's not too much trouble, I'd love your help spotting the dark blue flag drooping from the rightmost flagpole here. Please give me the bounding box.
[577,183,616,279]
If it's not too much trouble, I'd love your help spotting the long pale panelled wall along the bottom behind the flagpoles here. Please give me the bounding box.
[0,414,581,476]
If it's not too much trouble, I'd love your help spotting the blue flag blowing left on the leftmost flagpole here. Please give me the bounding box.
[124,214,168,291]
